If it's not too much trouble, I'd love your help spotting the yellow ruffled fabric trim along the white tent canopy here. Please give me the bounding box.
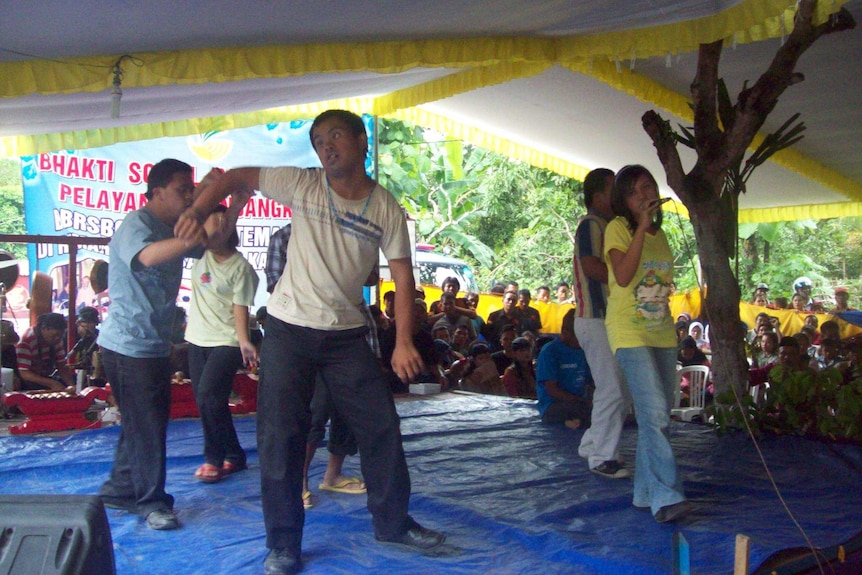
[0,0,862,222]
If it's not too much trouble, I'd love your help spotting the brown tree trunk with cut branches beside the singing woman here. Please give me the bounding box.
[641,0,856,395]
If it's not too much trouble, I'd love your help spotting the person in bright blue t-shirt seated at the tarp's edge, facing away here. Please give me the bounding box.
[536,309,593,429]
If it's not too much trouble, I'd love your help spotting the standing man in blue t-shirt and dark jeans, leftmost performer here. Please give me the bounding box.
[98,159,204,530]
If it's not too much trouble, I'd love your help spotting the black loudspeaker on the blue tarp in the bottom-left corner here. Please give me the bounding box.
[0,495,116,575]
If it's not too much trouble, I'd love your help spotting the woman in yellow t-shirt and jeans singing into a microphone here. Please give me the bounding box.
[604,165,691,523]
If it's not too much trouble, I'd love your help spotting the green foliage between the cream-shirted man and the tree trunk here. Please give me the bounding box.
[378,120,696,290]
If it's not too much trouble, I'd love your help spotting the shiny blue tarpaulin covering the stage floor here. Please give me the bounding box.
[0,394,862,575]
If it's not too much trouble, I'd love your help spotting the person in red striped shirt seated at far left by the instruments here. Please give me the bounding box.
[16,313,75,391]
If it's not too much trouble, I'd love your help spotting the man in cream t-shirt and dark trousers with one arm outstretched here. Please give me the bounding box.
[176,110,445,575]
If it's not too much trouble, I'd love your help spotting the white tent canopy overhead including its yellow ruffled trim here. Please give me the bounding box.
[0,0,862,221]
